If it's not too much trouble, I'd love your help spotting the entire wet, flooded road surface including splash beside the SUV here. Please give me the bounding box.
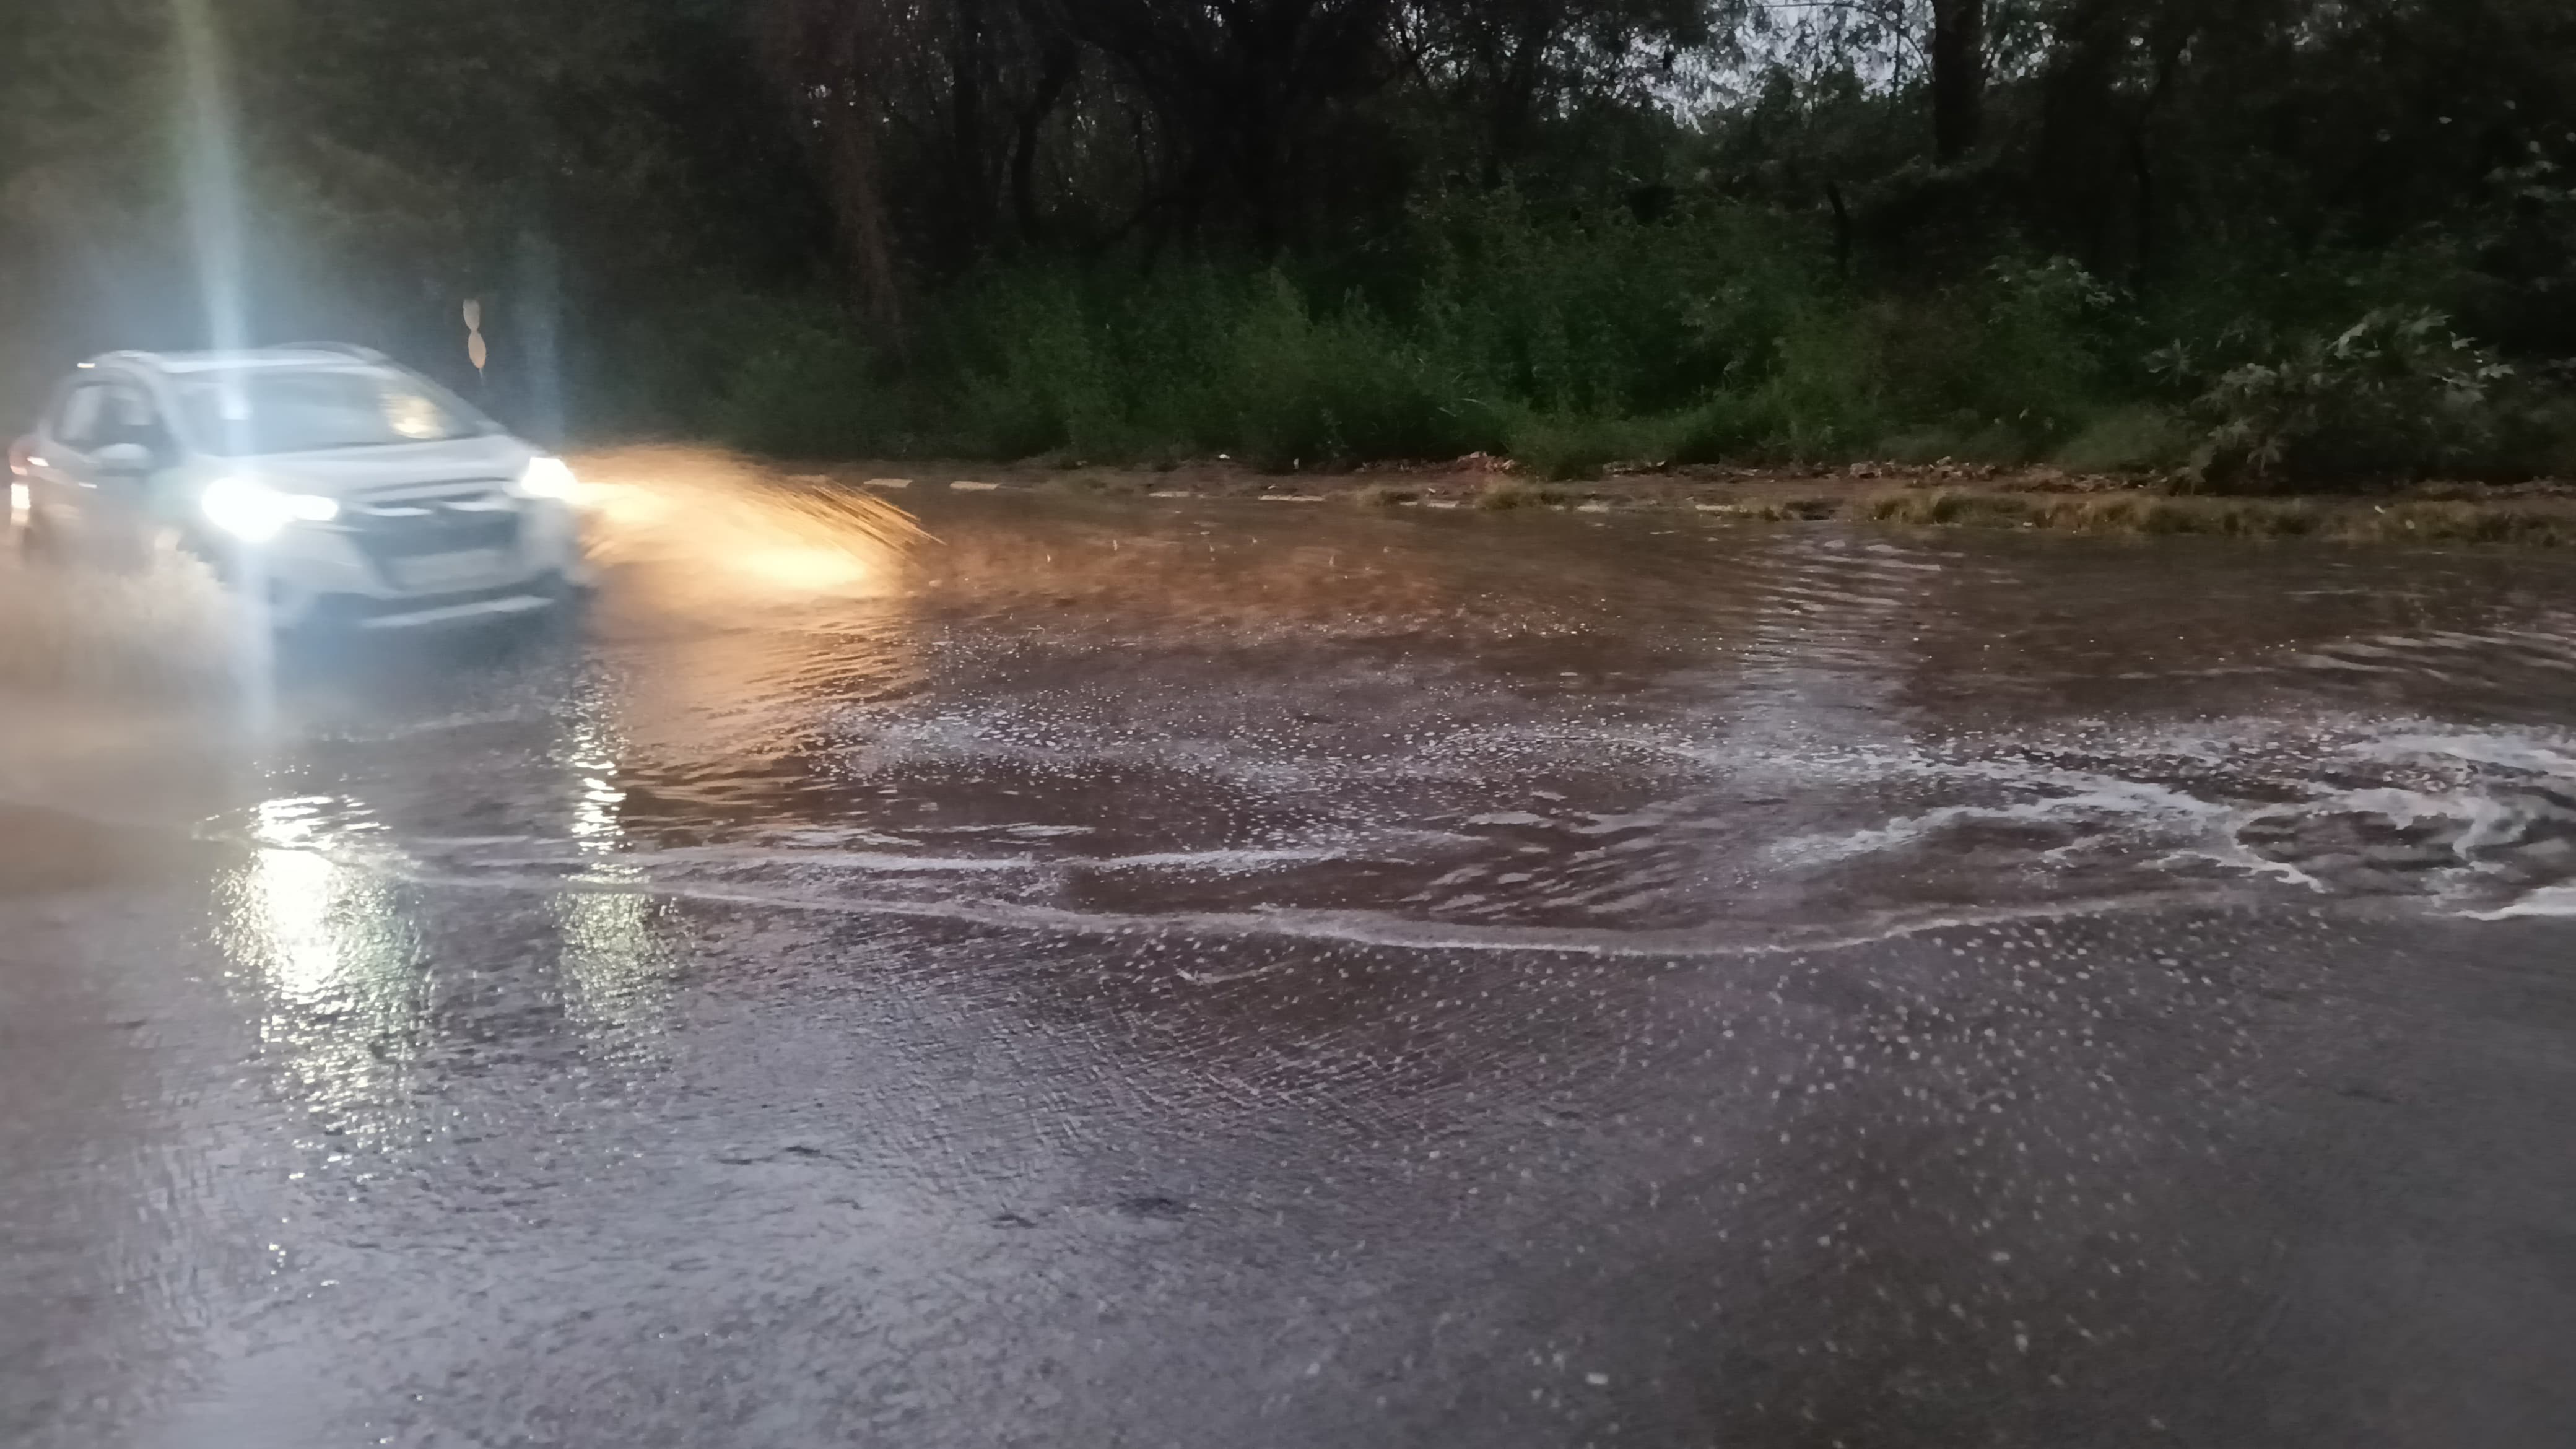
[0,454,2576,1449]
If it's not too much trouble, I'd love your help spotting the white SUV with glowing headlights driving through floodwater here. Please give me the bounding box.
[7,346,582,629]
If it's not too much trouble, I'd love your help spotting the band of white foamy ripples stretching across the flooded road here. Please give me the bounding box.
[166,696,2576,957]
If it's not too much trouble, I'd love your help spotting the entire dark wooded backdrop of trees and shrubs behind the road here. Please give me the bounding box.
[15,0,2576,490]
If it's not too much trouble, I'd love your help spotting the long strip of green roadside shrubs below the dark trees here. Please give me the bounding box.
[706,201,2576,490]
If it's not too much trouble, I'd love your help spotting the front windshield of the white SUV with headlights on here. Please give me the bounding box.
[175,368,492,456]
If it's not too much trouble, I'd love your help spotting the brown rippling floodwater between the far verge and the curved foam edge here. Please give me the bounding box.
[155,474,2576,954]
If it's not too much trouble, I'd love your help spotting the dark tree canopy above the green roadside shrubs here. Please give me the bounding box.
[0,0,2576,477]
